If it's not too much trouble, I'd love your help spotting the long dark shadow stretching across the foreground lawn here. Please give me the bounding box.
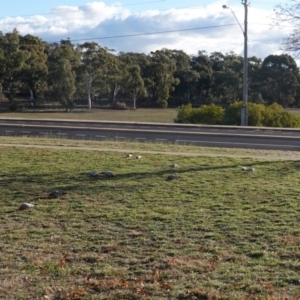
[0,161,284,197]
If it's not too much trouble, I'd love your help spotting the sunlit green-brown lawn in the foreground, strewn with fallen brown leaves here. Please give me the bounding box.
[0,146,300,300]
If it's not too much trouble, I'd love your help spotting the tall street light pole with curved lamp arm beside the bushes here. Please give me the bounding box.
[223,0,249,126]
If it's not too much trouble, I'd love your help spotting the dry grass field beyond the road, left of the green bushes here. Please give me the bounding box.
[0,108,177,123]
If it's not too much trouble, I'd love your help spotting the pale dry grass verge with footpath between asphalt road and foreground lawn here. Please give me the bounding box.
[0,135,300,160]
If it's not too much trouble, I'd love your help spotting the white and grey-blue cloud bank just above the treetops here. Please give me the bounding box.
[0,1,290,58]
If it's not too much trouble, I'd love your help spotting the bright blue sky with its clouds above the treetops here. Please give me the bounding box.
[0,0,292,58]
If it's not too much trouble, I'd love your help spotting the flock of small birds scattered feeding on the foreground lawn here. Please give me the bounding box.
[18,154,255,210]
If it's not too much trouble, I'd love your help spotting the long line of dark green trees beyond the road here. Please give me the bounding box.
[0,30,300,110]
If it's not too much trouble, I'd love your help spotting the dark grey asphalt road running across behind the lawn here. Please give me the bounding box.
[0,119,300,151]
